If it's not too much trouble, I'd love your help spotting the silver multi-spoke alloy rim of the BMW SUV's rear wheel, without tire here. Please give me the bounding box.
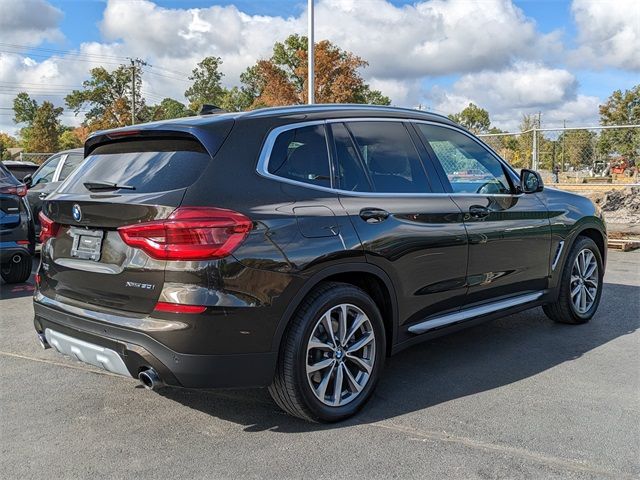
[306,303,376,407]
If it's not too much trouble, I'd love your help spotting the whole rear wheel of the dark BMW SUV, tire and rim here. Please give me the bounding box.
[269,282,386,422]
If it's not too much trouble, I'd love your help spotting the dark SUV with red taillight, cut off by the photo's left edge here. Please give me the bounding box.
[0,162,35,283]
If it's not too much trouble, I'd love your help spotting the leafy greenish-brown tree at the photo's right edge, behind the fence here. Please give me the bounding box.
[598,85,640,163]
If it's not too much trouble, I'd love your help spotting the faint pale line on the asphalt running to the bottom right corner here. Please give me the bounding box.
[368,422,635,479]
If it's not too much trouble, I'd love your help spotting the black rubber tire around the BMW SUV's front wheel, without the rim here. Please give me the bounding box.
[542,237,604,325]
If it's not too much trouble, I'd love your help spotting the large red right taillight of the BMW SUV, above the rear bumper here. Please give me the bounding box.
[118,207,252,260]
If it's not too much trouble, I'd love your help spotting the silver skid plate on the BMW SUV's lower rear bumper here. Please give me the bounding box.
[44,328,131,377]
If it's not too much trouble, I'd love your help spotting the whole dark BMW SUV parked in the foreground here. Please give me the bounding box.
[34,105,606,421]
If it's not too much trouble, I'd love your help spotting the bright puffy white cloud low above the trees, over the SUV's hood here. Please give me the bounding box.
[428,62,600,130]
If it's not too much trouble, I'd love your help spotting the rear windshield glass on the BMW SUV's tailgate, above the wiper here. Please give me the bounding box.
[60,138,211,194]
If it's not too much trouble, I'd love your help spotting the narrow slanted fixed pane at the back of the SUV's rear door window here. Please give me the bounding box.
[331,123,372,192]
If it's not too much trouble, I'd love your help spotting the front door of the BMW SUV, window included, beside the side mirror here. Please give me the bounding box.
[415,123,551,304]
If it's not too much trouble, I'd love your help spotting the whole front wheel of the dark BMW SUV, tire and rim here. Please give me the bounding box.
[543,237,603,324]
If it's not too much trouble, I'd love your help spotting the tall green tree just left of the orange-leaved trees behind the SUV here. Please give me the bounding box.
[184,57,226,112]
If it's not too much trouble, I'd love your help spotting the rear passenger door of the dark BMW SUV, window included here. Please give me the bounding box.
[330,119,467,327]
